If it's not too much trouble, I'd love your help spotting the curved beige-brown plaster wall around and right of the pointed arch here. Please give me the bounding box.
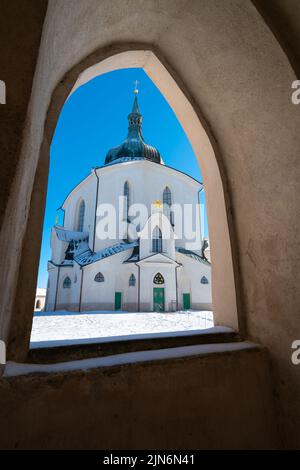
[1,0,300,446]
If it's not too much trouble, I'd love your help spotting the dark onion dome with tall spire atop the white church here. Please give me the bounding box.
[104,90,161,165]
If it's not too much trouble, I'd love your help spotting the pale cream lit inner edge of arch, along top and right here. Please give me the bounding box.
[9,50,238,360]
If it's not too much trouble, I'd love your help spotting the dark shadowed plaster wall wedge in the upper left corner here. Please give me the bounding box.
[0,0,47,227]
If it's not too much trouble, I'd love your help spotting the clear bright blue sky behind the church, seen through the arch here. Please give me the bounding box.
[38,69,207,287]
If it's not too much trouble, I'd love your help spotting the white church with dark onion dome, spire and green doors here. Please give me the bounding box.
[45,89,212,312]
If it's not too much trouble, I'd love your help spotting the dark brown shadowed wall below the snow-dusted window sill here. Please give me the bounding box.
[0,351,280,450]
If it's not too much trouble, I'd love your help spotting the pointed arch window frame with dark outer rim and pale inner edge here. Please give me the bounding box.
[8,49,241,360]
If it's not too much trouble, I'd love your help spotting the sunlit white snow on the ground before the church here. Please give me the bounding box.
[30,311,214,347]
